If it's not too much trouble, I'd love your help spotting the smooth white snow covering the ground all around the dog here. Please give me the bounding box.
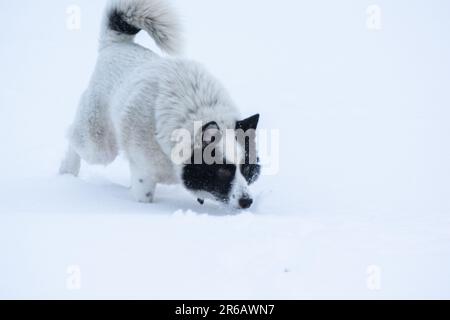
[0,0,450,299]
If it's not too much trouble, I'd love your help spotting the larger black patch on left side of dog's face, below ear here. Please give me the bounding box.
[182,159,237,203]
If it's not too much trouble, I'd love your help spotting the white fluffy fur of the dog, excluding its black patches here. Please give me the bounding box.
[60,0,249,206]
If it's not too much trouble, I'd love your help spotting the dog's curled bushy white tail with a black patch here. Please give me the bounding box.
[100,0,182,54]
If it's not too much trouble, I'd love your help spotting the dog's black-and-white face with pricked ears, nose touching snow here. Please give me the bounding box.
[182,115,261,209]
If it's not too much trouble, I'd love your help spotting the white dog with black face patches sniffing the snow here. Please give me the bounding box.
[60,0,261,209]
